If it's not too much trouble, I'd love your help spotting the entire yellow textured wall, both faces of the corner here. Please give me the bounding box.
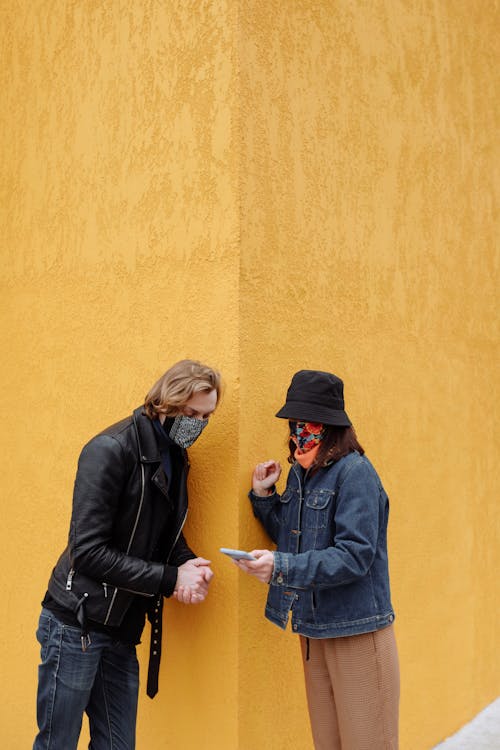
[0,0,500,750]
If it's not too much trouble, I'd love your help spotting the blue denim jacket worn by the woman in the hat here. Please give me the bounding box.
[249,452,394,638]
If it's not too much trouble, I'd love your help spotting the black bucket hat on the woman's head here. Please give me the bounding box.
[276,370,352,427]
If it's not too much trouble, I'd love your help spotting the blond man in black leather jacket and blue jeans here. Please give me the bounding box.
[33,360,220,750]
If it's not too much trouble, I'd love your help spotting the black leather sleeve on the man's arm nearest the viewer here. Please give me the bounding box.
[69,435,165,594]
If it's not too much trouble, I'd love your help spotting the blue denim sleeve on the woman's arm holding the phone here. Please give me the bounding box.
[271,461,385,588]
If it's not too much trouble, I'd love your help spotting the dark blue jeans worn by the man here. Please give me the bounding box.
[33,609,139,750]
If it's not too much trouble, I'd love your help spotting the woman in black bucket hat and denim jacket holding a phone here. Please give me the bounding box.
[237,370,399,750]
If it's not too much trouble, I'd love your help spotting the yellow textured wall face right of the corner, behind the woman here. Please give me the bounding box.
[240,0,500,750]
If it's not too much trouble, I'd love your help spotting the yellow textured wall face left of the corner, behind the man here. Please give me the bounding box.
[0,0,239,750]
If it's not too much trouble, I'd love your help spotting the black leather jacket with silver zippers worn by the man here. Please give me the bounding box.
[48,407,195,626]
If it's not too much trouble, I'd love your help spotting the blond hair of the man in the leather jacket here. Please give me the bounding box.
[144,359,221,419]
